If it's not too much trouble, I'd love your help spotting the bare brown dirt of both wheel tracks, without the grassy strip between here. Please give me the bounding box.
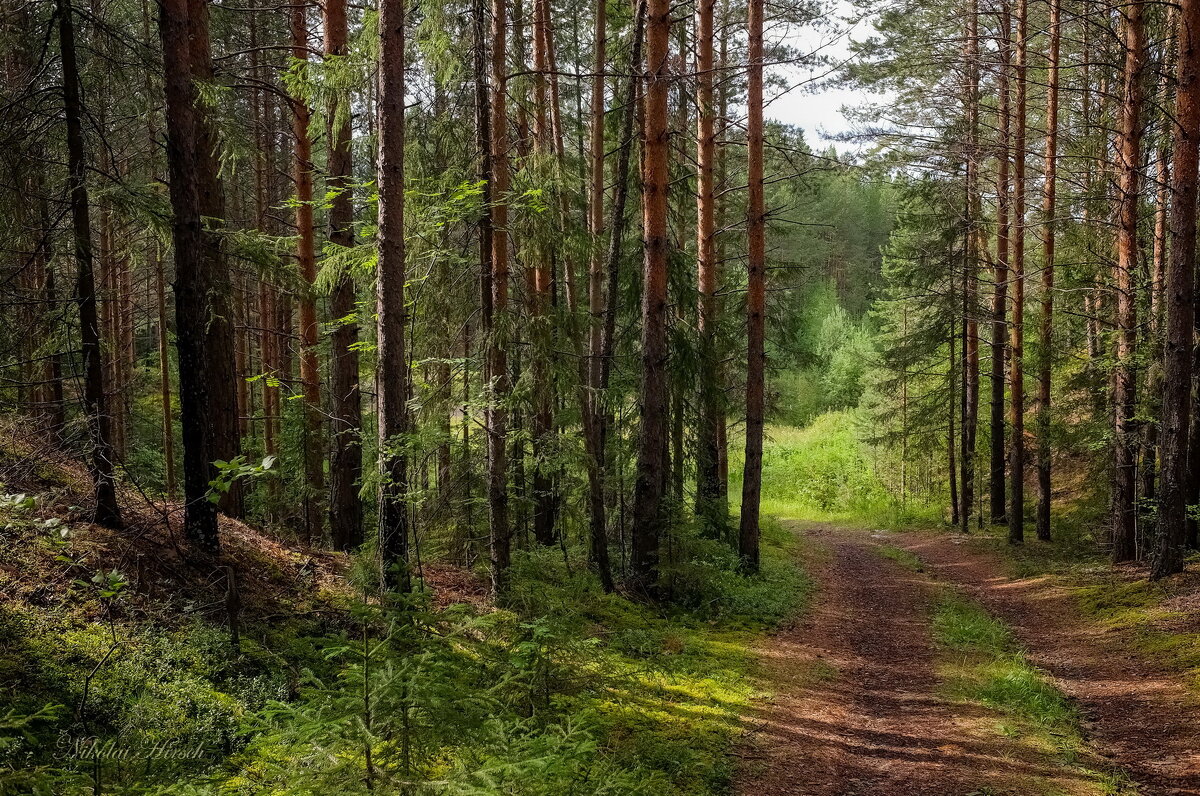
[736,525,1200,796]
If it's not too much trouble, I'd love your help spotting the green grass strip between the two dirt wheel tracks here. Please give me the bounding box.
[932,588,1133,794]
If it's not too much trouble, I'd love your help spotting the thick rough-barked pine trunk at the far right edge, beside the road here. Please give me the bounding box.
[1151,0,1200,579]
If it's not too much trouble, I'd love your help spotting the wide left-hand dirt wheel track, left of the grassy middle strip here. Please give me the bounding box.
[737,527,1094,796]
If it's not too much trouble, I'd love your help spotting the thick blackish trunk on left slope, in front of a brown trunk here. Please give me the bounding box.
[158,0,220,552]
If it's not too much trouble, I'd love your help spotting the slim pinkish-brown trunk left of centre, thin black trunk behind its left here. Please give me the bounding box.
[486,0,512,595]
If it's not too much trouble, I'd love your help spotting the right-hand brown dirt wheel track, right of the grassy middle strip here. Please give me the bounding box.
[889,534,1200,795]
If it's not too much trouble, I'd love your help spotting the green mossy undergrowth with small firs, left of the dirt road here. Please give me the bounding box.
[0,489,809,796]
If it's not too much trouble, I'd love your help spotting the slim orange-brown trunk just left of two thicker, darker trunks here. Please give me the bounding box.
[290,1,325,539]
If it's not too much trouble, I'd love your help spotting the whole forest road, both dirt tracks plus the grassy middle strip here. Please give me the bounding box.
[737,523,1200,796]
